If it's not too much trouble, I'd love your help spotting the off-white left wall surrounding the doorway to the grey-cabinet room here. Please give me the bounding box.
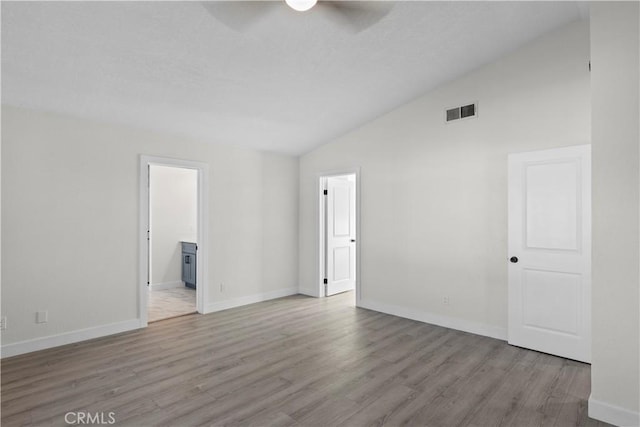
[2,106,298,356]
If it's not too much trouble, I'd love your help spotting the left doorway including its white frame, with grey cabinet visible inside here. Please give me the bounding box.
[138,156,208,327]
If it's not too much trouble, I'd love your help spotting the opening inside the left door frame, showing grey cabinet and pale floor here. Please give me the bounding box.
[147,164,198,322]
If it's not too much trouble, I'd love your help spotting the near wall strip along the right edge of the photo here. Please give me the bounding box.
[589,2,640,426]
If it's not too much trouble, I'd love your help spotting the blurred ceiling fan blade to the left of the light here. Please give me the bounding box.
[201,1,280,32]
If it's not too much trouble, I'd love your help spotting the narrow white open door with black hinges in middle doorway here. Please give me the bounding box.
[325,176,356,295]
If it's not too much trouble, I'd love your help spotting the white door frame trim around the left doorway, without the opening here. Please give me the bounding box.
[138,154,209,328]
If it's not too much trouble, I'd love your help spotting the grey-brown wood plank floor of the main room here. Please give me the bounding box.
[2,294,603,427]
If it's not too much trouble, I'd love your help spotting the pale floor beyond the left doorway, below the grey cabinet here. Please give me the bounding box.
[147,286,196,322]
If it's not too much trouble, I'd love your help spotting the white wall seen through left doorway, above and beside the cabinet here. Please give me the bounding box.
[149,165,198,288]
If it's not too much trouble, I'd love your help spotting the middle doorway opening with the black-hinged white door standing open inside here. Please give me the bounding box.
[318,170,360,304]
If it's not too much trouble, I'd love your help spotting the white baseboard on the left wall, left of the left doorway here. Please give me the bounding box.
[2,319,141,358]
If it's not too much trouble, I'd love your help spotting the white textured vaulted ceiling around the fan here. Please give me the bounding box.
[2,1,584,154]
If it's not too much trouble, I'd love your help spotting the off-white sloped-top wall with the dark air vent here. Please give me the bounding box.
[300,22,590,338]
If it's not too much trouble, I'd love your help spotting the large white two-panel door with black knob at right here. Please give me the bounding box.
[505,145,591,362]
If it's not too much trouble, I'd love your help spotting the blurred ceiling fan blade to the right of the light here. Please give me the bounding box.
[316,1,396,33]
